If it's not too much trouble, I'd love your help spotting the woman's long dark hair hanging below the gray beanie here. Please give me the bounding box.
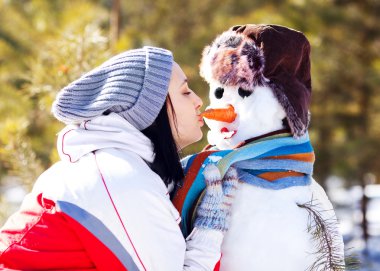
[141,96,184,186]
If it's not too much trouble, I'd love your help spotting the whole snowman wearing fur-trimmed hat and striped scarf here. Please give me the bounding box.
[173,25,345,271]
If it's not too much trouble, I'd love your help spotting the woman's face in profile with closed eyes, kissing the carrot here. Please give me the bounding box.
[167,62,204,149]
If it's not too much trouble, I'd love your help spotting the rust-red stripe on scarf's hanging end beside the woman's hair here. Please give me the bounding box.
[173,151,216,213]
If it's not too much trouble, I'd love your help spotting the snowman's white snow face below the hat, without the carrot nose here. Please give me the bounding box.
[205,82,286,149]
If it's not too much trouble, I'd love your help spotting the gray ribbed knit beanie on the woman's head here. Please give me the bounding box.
[52,47,173,130]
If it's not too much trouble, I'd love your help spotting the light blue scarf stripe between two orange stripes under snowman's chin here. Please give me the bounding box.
[233,159,313,175]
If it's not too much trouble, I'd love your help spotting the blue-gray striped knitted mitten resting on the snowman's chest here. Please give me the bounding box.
[194,164,238,232]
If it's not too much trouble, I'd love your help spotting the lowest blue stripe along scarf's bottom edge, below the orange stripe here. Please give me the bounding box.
[238,170,311,190]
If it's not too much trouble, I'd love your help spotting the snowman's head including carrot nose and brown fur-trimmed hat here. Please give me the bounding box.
[200,25,311,149]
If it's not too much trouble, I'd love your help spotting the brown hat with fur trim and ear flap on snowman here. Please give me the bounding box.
[200,24,311,137]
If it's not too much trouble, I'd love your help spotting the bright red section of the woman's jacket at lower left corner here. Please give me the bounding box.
[0,194,126,271]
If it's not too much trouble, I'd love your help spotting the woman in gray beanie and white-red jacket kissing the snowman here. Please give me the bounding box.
[0,47,234,271]
